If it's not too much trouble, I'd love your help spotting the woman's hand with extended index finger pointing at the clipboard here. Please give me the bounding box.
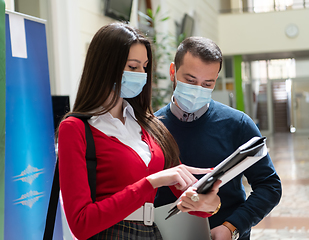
[146,164,211,191]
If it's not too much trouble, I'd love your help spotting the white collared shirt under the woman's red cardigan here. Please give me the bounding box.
[88,100,151,166]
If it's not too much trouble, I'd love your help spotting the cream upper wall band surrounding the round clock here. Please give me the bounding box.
[219,9,309,55]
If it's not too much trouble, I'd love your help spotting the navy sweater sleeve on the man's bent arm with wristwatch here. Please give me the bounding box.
[225,116,282,237]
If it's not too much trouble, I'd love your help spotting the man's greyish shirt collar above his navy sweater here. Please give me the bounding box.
[170,95,209,122]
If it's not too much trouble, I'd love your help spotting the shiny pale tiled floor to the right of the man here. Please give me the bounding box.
[245,133,309,240]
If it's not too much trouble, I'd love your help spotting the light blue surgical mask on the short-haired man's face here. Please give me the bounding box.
[174,80,213,113]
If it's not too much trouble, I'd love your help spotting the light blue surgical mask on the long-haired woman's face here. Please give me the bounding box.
[120,71,147,98]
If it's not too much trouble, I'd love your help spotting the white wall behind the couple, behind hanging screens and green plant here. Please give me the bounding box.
[51,0,219,105]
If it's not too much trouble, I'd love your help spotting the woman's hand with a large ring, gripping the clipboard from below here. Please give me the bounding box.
[177,180,221,213]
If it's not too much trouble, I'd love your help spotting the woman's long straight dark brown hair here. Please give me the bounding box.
[62,23,179,168]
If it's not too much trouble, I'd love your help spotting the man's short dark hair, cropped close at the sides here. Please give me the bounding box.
[174,37,222,72]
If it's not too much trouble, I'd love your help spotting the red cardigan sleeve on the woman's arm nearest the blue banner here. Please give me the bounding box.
[58,118,155,240]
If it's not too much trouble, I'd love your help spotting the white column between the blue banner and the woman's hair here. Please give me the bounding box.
[49,0,83,108]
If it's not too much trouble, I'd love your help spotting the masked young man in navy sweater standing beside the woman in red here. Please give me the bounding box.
[155,37,282,240]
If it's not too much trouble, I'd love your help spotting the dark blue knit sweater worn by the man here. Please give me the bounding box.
[155,100,282,240]
